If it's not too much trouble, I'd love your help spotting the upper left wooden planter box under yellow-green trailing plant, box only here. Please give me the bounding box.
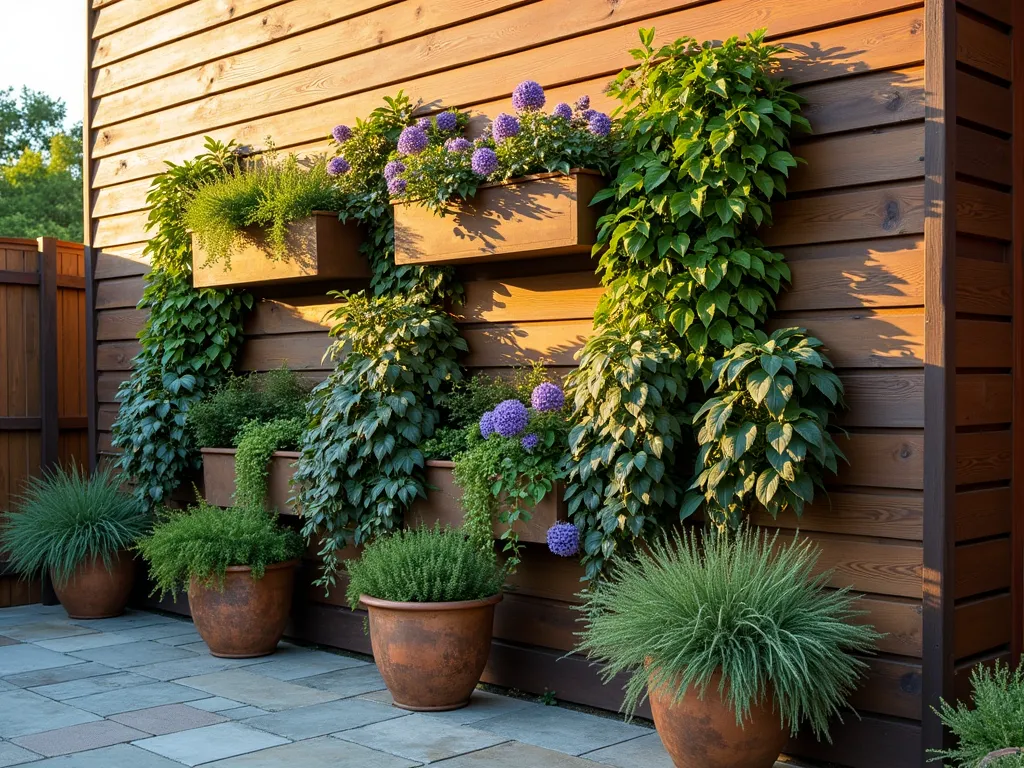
[193,211,371,288]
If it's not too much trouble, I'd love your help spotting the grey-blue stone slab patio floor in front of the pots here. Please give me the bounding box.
[0,605,672,768]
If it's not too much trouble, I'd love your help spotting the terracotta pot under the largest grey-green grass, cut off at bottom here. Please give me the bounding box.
[650,674,790,768]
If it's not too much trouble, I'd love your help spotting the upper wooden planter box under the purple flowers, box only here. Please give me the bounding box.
[394,171,605,264]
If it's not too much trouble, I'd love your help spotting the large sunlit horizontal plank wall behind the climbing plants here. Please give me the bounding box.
[87,0,933,768]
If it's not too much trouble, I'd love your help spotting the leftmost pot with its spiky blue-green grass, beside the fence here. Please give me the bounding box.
[0,466,150,618]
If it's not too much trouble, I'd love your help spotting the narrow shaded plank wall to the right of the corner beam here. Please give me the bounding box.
[953,0,1016,698]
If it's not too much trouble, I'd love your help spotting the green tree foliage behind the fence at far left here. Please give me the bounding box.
[0,88,84,242]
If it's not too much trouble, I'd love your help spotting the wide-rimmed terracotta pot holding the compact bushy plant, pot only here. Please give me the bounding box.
[359,594,502,712]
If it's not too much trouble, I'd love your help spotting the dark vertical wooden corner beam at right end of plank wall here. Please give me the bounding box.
[921,0,956,766]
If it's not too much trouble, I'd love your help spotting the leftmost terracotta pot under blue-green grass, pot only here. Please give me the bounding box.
[50,550,135,618]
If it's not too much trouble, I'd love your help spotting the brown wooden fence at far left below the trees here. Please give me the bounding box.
[0,238,88,608]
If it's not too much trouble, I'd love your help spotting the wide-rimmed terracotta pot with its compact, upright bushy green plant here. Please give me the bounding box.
[346,525,505,712]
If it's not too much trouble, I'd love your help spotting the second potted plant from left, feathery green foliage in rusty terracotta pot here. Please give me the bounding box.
[138,502,303,658]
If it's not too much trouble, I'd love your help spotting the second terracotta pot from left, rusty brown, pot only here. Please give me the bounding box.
[188,560,299,658]
